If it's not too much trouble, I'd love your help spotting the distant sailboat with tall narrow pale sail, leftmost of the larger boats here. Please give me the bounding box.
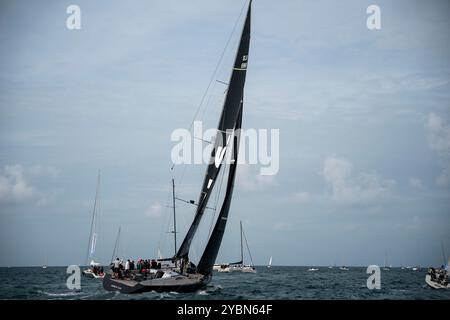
[82,171,104,278]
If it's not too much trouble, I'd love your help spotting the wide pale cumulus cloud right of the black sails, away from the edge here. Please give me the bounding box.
[322,157,395,205]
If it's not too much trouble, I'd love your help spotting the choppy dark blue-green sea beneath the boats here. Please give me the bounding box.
[0,266,450,300]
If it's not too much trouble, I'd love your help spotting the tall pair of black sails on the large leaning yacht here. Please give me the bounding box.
[174,1,251,268]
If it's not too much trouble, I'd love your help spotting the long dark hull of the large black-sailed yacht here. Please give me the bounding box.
[103,274,210,294]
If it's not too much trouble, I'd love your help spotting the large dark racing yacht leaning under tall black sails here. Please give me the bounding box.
[103,0,255,293]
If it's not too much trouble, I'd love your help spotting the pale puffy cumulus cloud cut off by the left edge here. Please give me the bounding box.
[0,164,36,203]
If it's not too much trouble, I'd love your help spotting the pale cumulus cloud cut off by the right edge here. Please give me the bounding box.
[426,113,450,186]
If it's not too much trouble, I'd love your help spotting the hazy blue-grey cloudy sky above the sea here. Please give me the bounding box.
[0,0,450,266]
